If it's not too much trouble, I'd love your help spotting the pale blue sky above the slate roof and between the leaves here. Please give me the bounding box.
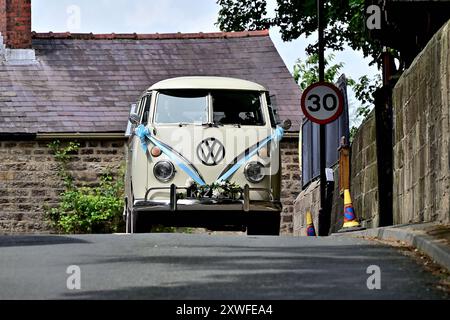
[32,0,378,126]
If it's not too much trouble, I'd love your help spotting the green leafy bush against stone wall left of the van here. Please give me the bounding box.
[47,141,124,233]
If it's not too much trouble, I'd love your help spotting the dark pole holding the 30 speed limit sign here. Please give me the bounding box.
[317,0,330,236]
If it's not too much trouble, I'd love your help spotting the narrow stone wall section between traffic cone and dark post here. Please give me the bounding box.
[350,110,379,228]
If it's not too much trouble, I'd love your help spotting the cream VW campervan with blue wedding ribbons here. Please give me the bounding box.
[124,77,290,235]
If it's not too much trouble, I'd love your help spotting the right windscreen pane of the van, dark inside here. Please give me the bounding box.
[211,90,265,126]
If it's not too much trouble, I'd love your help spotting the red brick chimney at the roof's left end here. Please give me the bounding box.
[0,0,31,49]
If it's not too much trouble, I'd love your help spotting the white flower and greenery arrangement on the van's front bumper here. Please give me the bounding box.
[180,181,243,200]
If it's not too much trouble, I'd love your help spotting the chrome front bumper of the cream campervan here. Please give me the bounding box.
[133,185,282,212]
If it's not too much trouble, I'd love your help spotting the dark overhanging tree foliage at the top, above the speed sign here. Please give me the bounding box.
[217,0,382,61]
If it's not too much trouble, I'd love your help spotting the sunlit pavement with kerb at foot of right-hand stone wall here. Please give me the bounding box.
[333,223,450,272]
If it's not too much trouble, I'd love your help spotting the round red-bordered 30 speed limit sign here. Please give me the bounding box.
[301,82,344,124]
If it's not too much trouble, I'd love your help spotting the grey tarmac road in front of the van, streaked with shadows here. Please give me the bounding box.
[0,234,447,300]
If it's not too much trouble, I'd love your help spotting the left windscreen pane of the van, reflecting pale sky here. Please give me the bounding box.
[155,90,208,123]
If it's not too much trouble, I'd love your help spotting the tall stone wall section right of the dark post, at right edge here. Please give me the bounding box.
[393,21,450,224]
